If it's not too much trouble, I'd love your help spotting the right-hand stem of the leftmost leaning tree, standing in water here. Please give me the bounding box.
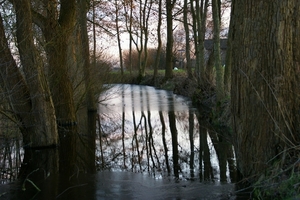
[13,0,58,147]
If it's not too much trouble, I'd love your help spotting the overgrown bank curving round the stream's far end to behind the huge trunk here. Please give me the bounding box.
[106,70,233,136]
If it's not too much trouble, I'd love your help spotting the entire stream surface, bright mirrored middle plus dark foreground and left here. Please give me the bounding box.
[0,85,236,199]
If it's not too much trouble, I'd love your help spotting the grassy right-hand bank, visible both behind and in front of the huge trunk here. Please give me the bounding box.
[129,74,300,199]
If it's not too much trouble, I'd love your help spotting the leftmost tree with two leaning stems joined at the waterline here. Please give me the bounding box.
[0,0,58,148]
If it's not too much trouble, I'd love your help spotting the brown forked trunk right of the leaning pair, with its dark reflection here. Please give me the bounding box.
[37,0,77,173]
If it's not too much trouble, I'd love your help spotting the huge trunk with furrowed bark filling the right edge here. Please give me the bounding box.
[231,0,300,183]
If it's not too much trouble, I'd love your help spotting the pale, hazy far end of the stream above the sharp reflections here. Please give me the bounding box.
[99,84,192,113]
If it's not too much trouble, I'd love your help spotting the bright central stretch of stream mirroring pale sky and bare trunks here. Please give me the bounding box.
[97,85,235,182]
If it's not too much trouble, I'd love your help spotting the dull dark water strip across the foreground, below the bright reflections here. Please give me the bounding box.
[0,171,233,200]
